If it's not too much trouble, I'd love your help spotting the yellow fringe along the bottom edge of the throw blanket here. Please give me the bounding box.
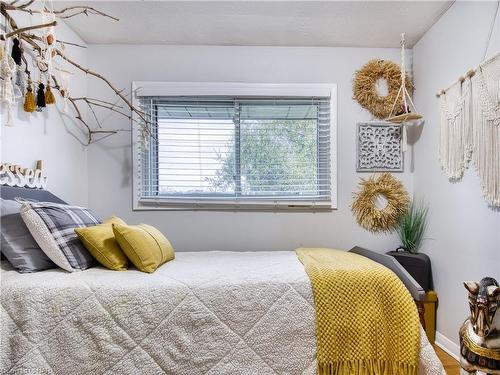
[318,359,418,375]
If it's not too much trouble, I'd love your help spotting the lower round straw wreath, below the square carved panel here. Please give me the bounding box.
[351,173,410,233]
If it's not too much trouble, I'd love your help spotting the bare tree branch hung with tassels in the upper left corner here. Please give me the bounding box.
[0,0,150,144]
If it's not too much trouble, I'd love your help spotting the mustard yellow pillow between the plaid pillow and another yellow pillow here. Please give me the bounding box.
[75,216,128,271]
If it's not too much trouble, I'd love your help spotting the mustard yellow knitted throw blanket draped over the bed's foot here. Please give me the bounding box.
[295,248,420,375]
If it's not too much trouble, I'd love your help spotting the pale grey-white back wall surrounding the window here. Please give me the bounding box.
[88,45,412,251]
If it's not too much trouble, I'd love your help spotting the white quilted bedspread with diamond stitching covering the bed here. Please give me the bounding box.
[1,252,444,375]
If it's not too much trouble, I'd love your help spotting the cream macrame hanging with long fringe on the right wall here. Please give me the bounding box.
[437,1,500,207]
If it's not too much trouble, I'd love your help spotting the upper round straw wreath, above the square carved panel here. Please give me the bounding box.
[352,59,412,119]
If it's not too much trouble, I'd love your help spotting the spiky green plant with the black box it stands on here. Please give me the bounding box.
[387,200,432,291]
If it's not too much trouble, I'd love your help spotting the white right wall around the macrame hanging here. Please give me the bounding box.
[413,2,500,350]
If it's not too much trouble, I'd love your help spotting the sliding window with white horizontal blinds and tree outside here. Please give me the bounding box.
[134,83,334,210]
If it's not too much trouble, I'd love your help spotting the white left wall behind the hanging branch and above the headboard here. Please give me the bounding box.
[0,14,88,205]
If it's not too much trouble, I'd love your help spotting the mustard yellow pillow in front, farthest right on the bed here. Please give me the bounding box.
[113,224,175,273]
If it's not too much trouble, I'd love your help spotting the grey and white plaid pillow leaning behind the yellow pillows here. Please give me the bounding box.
[21,202,102,272]
